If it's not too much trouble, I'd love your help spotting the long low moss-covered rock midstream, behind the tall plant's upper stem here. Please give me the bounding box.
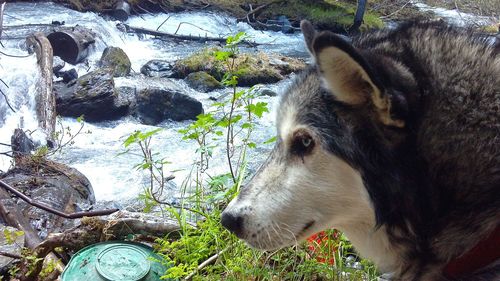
[172,48,306,86]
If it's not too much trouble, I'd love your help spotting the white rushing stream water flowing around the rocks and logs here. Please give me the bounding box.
[0,3,307,202]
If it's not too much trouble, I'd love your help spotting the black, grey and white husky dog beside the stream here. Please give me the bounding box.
[221,21,500,280]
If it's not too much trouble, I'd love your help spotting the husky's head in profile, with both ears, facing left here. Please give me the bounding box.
[222,22,411,249]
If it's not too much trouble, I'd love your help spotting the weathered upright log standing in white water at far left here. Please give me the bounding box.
[26,32,56,140]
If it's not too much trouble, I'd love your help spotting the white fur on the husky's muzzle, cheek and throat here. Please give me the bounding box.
[226,118,398,271]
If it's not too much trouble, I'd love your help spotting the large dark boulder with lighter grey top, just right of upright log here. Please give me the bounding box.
[54,68,128,122]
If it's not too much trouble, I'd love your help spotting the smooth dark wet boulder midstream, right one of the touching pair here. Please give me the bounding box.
[135,88,203,125]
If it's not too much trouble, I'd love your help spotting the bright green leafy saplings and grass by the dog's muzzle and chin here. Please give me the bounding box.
[124,33,377,280]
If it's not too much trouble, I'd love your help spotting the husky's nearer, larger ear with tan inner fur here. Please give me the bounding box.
[311,31,404,128]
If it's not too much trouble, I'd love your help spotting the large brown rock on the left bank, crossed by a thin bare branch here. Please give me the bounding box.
[1,157,95,239]
